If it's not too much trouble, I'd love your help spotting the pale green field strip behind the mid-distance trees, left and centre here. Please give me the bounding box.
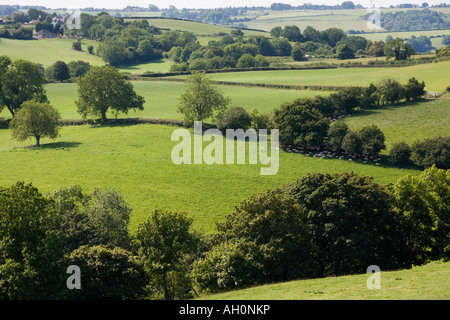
[0,81,330,119]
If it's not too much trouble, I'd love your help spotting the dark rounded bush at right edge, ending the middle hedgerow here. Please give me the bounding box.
[411,136,450,169]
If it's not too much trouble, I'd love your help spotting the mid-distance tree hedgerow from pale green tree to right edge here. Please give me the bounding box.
[174,73,442,168]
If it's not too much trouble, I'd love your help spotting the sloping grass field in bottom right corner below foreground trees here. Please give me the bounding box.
[200,262,450,300]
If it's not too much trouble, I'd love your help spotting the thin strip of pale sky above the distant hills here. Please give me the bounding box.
[0,0,449,9]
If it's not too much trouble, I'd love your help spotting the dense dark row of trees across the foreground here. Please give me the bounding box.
[0,167,450,299]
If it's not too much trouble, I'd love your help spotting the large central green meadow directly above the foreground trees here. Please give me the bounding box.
[0,124,420,232]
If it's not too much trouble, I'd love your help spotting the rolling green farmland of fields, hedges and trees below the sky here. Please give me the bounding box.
[0,4,450,300]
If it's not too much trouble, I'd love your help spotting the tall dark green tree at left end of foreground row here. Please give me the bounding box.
[0,182,65,300]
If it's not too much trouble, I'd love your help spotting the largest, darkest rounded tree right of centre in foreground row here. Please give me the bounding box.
[286,173,405,276]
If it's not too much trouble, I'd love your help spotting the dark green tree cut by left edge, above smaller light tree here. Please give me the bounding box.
[0,56,47,117]
